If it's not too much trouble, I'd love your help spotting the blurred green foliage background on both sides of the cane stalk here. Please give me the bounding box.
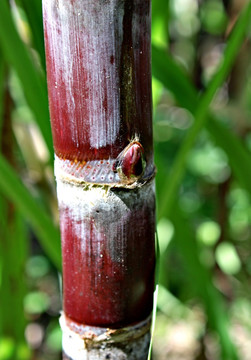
[0,0,251,360]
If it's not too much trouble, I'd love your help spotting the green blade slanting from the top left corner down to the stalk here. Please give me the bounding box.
[0,0,53,161]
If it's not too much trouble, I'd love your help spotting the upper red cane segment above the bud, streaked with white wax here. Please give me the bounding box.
[44,0,152,165]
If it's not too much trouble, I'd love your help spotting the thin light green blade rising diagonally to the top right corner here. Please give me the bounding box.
[156,3,251,216]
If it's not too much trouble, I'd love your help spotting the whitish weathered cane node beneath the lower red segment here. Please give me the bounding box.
[60,314,151,360]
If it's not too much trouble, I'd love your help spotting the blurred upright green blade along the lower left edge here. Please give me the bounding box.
[0,204,28,352]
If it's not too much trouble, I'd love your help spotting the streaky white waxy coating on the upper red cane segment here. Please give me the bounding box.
[43,0,123,149]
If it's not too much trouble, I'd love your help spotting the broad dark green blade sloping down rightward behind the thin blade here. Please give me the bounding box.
[153,47,251,198]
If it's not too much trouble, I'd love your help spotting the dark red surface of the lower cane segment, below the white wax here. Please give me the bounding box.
[61,194,155,327]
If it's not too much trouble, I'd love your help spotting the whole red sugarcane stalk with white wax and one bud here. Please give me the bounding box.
[43,0,155,360]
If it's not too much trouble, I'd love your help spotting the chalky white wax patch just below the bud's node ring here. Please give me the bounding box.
[55,166,155,268]
